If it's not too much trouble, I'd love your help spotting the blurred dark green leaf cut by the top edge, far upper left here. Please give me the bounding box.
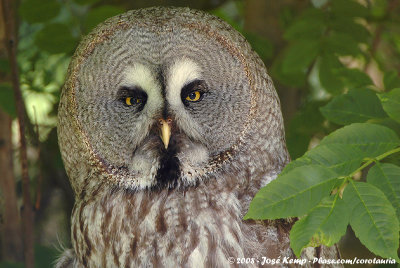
[19,0,60,23]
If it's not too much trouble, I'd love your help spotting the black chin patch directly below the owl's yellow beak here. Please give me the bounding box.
[155,142,180,189]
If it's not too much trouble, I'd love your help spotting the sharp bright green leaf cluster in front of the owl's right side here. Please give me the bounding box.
[244,123,400,259]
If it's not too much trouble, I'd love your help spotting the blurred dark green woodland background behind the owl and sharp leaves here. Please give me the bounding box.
[0,0,400,267]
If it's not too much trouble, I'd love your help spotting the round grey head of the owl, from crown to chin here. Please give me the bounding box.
[58,8,288,193]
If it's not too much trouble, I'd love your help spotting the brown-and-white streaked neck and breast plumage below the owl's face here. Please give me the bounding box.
[72,164,282,267]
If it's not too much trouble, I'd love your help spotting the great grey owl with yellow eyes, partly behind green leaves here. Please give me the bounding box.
[57,8,340,267]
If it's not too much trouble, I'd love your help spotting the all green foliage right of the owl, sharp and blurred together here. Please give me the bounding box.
[244,0,400,261]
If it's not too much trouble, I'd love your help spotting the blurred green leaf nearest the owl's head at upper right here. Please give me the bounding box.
[282,39,319,73]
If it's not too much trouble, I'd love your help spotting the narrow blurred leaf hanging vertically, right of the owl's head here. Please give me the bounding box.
[319,54,344,95]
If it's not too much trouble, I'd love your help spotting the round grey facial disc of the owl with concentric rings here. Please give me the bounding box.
[70,15,252,190]
